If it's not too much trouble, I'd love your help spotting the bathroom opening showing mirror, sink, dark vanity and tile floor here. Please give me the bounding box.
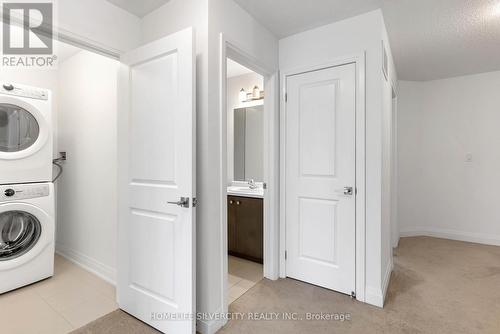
[226,58,266,304]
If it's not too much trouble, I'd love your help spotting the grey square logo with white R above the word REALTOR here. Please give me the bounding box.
[3,2,53,55]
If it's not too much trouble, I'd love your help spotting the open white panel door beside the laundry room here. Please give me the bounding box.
[117,29,196,334]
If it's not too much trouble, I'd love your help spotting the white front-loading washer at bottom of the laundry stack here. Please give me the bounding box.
[0,183,55,294]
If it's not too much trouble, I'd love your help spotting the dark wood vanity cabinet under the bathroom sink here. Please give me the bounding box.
[227,196,264,263]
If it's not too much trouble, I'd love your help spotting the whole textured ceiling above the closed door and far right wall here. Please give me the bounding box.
[235,0,500,80]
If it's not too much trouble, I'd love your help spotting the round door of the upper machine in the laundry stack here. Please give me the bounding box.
[0,96,49,160]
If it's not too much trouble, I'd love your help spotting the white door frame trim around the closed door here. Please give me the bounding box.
[279,52,366,302]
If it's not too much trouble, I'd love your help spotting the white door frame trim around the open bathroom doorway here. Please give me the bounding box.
[219,33,280,313]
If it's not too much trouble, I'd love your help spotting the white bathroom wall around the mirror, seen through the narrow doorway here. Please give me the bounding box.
[227,73,264,184]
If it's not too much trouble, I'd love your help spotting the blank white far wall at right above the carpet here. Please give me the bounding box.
[398,72,500,245]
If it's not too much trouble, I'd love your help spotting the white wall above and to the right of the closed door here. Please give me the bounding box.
[279,10,395,306]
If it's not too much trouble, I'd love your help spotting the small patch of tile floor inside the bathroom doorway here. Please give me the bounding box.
[228,256,263,304]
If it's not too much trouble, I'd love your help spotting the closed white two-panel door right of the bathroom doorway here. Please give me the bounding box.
[285,64,356,294]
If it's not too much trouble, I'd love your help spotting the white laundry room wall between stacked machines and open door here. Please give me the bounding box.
[56,51,118,281]
